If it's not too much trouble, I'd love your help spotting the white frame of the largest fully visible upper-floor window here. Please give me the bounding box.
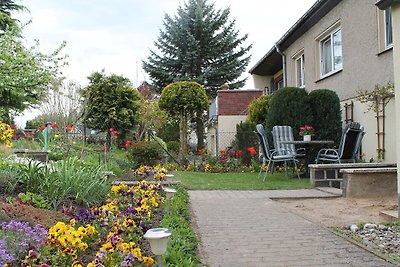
[319,27,343,78]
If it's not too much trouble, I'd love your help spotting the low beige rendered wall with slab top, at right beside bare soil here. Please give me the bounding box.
[340,167,397,198]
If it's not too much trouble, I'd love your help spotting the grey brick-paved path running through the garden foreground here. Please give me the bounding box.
[189,191,394,267]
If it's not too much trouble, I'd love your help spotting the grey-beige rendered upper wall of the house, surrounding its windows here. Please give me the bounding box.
[284,0,393,100]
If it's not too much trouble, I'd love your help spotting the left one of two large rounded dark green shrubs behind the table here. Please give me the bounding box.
[265,87,312,138]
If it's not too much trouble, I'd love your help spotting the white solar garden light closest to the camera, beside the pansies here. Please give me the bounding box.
[143,228,171,267]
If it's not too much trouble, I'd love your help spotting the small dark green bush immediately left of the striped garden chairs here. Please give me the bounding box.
[235,121,258,166]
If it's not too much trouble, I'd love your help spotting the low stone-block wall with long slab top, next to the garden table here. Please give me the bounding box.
[308,162,397,188]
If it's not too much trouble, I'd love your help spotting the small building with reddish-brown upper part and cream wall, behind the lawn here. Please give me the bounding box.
[207,90,263,155]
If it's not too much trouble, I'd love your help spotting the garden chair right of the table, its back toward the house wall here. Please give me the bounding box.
[315,122,365,163]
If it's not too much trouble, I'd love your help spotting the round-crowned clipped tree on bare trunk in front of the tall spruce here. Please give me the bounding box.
[159,81,208,154]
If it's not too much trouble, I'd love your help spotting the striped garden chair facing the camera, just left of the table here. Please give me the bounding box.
[272,125,305,158]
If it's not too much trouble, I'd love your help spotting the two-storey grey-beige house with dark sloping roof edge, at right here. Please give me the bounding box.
[250,0,396,162]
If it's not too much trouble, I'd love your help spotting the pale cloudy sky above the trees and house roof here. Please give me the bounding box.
[15,0,316,126]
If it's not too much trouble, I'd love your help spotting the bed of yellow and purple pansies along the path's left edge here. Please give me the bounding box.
[0,181,164,267]
